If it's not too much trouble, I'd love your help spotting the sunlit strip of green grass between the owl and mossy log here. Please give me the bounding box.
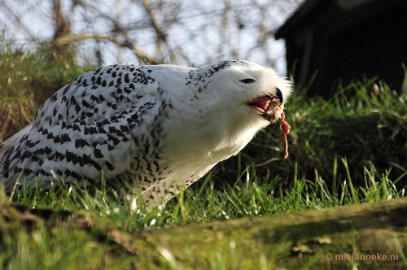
[9,156,407,231]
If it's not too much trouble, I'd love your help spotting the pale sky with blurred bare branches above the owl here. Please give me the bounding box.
[0,0,302,73]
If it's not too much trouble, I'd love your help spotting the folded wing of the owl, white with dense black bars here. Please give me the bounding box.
[0,65,168,186]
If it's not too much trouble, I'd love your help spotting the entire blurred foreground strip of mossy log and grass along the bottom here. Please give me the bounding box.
[0,198,407,269]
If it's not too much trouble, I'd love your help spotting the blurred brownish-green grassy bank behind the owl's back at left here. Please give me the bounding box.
[0,36,89,142]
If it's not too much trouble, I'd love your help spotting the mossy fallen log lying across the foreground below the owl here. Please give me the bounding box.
[0,195,407,269]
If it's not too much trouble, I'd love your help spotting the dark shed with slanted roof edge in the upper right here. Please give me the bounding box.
[275,0,407,96]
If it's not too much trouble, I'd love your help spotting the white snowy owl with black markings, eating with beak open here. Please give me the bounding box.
[0,60,291,208]
